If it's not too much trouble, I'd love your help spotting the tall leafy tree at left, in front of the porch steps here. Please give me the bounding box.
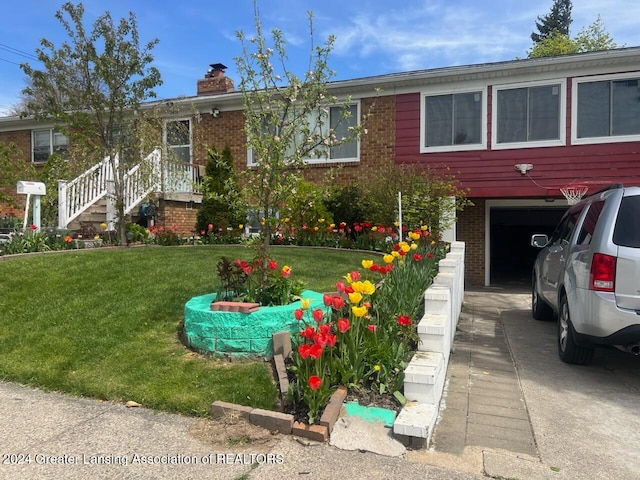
[22,2,162,244]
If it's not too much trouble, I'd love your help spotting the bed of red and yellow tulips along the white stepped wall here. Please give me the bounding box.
[289,229,444,423]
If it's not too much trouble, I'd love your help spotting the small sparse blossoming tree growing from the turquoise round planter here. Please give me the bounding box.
[236,3,364,258]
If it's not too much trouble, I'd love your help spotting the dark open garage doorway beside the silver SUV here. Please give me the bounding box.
[489,206,567,286]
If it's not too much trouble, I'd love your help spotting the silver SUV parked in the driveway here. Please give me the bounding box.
[531,184,640,364]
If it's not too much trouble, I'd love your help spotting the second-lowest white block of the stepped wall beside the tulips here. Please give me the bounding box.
[404,351,446,407]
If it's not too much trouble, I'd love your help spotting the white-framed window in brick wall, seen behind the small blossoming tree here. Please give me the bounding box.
[247,103,360,166]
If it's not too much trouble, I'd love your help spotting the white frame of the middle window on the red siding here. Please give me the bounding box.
[491,78,567,150]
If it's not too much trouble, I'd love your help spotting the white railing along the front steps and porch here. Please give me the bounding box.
[58,149,201,229]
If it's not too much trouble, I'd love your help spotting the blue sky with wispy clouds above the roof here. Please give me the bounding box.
[0,0,640,115]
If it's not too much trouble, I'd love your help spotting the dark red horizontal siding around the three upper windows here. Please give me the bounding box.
[395,91,640,198]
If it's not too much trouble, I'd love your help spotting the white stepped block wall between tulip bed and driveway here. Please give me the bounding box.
[393,242,465,445]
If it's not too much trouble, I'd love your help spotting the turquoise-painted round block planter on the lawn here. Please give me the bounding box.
[184,290,331,358]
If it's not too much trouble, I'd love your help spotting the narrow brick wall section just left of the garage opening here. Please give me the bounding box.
[456,198,485,286]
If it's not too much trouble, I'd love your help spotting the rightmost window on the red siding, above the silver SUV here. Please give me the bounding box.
[575,77,640,141]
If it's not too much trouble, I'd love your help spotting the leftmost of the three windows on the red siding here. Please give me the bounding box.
[421,91,486,152]
